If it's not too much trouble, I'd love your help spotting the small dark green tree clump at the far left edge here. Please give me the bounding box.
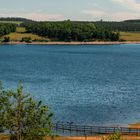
[0,23,16,36]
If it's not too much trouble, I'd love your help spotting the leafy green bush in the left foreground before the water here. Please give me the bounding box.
[0,83,53,140]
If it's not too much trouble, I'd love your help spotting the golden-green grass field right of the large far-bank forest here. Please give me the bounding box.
[120,32,140,41]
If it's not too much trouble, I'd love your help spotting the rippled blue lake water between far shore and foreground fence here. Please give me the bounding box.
[0,45,140,125]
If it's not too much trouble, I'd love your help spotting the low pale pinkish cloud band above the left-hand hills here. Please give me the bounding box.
[0,9,64,21]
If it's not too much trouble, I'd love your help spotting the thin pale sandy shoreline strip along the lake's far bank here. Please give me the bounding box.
[0,41,140,45]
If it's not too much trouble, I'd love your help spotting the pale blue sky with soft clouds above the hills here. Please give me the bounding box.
[0,0,140,21]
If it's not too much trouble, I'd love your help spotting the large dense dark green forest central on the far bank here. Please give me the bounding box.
[25,20,119,41]
